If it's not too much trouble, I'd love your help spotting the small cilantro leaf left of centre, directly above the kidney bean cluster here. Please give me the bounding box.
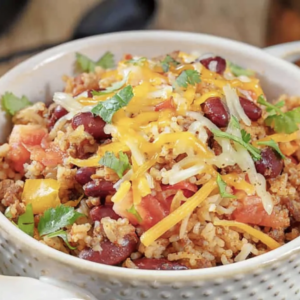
[99,151,131,178]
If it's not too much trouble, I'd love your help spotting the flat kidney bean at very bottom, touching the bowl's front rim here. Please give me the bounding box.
[133,257,188,270]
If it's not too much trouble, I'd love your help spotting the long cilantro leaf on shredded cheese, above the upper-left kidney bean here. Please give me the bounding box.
[92,85,134,123]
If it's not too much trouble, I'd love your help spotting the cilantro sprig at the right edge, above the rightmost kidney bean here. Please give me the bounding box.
[257,95,300,134]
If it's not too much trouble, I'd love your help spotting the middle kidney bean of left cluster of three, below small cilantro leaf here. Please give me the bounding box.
[83,179,116,197]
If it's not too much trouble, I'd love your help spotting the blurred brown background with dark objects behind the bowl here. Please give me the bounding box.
[0,0,300,76]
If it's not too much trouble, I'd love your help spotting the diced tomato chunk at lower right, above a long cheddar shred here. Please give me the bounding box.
[232,196,289,228]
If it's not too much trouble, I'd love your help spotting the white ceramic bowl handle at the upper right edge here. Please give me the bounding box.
[264,41,300,62]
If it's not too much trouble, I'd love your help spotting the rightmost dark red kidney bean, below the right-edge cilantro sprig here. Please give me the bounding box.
[255,147,283,179]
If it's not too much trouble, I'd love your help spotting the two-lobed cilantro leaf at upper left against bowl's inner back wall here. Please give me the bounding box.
[76,52,115,72]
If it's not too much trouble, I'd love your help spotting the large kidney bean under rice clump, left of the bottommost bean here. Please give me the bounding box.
[79,235,137,266]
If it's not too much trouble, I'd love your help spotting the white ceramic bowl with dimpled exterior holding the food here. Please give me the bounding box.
[0,31,300,300]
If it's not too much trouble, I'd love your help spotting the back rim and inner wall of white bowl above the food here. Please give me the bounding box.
[0,31,300,143]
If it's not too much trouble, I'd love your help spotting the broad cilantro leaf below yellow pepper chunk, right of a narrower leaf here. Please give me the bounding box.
[38,205,84,236]
